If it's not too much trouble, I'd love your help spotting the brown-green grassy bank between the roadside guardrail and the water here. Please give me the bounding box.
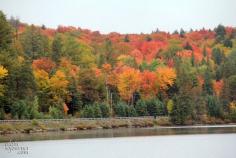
[0,118,160,134]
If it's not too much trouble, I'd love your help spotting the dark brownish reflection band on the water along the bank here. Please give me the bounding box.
[0,124,236,143]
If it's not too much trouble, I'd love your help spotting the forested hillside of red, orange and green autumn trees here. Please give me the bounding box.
[0,12,236,124]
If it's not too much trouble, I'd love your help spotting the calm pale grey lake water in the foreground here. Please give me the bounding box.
[0,126,236,158]
